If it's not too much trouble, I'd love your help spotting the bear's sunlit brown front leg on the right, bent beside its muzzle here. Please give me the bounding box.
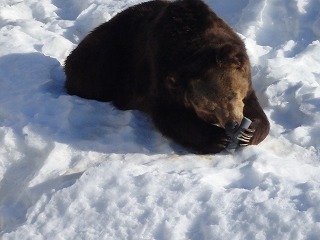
[243,91,270,145]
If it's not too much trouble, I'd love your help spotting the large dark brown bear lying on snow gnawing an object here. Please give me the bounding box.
[65,0,269,153]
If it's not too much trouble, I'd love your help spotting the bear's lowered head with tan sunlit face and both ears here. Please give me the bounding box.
[166,45,251,131]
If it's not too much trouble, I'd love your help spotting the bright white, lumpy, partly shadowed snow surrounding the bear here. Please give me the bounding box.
[0,0,320,240]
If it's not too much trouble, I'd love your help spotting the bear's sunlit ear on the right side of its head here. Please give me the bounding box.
[216,44,247,70]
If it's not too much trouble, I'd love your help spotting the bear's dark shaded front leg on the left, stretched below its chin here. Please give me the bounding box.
[152,107,230,154]
